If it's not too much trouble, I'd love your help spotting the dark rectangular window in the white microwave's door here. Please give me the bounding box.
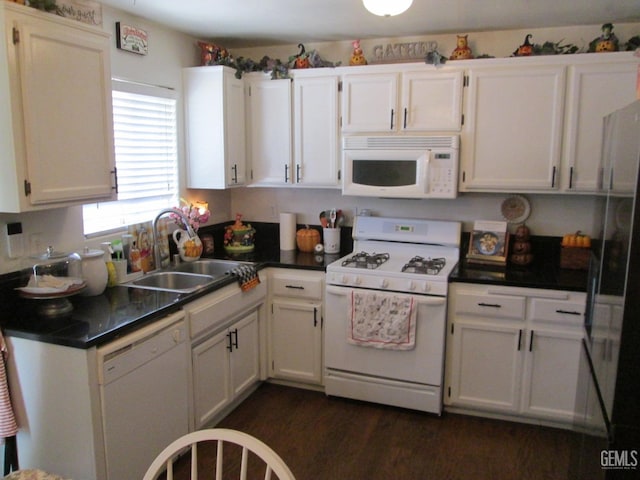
[352,160,418,187]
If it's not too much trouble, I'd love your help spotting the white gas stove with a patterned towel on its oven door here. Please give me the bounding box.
[324,217,461,414]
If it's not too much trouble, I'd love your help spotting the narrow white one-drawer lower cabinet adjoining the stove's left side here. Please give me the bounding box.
[269,269,324,385]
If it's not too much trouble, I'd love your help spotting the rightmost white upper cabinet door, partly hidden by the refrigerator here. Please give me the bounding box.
[562,62,638,192]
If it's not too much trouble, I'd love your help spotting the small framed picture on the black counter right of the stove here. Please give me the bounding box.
[467,220,509,265]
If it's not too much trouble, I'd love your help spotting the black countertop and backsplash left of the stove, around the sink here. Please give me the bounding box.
[0,224,352,349]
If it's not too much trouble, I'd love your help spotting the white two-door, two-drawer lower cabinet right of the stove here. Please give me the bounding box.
[444,283,586,423]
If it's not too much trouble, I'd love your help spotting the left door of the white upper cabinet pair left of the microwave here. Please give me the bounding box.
[247,79,295,186]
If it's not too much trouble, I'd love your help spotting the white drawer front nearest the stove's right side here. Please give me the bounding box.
[455,293,526,320]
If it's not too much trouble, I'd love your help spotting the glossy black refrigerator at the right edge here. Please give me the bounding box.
[575,101,640,480]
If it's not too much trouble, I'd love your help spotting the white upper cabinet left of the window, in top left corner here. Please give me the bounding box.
[0,2,117,212]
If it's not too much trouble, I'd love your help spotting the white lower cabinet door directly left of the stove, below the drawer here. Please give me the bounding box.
[271,299,322,384]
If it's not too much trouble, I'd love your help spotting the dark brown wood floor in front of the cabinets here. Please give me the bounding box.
[169,384,580,480]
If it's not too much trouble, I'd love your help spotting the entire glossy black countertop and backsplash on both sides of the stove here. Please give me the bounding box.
[0,223,587,349]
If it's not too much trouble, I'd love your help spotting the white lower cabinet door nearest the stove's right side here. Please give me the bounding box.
[447,321,522,412]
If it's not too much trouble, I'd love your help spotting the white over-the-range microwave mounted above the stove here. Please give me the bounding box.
[342,135,460,198]
